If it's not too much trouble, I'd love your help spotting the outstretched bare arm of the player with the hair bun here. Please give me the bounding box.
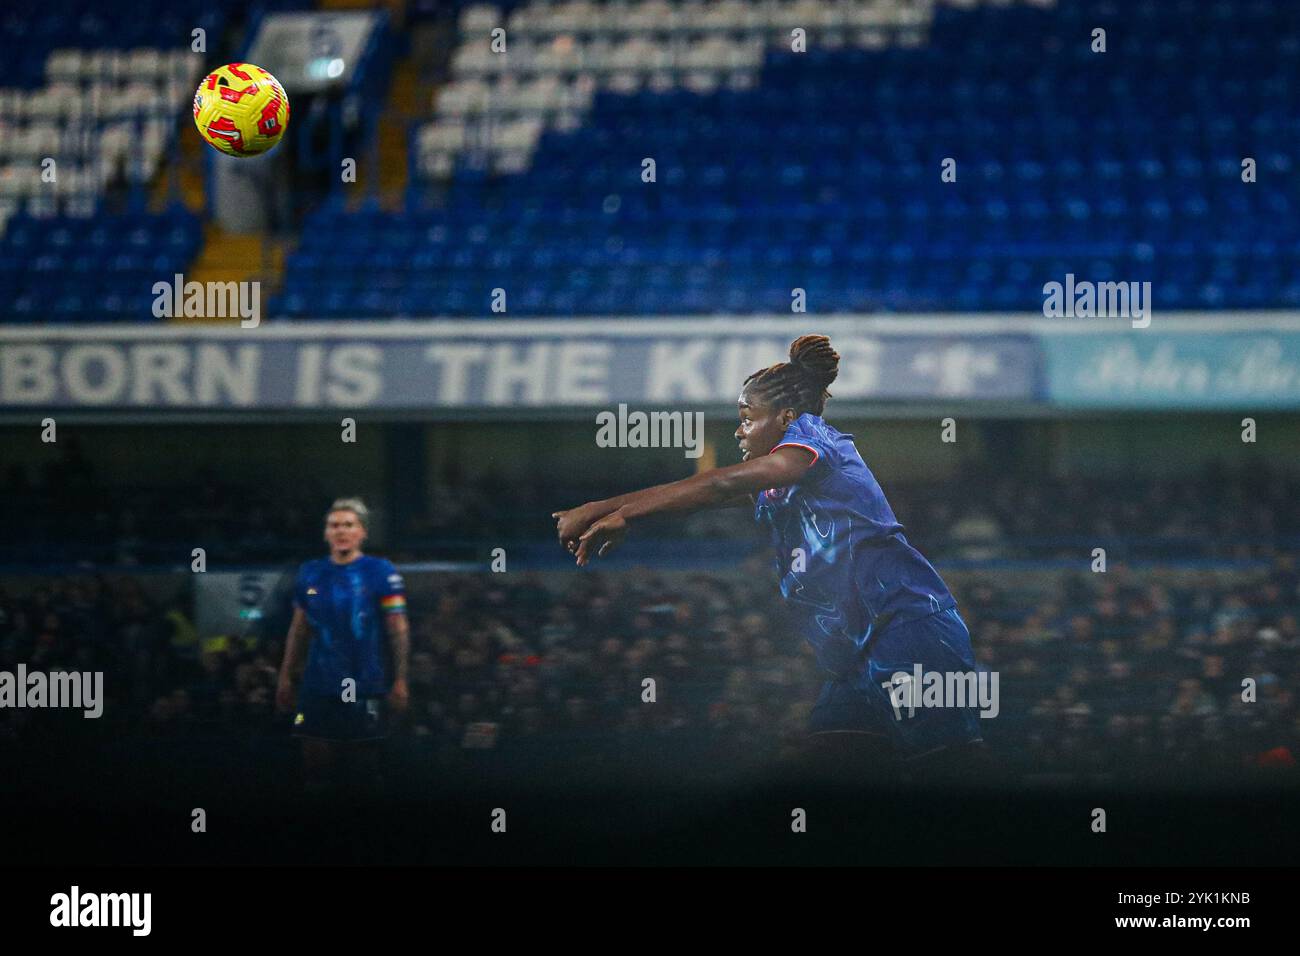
[559,446,815,564]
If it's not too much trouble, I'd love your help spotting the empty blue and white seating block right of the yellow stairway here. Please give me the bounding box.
[274,0,1300,317]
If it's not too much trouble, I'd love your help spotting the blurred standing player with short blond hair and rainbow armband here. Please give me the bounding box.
[276,498,410,792]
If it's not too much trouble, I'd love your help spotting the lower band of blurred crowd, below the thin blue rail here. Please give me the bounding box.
[0,554,1300,774]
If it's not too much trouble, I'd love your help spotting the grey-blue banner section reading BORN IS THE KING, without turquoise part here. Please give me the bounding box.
[0,320,1040,410]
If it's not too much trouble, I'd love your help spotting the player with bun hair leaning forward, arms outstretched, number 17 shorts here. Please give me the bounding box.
[553,336,983,765]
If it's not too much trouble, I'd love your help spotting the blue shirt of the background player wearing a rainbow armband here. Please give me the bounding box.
[294,555,406,697]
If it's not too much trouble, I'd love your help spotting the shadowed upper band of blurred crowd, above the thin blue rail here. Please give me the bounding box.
[0,436,1300,567]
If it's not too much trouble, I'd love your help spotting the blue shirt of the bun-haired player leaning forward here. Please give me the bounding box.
[754,412,957,676]
